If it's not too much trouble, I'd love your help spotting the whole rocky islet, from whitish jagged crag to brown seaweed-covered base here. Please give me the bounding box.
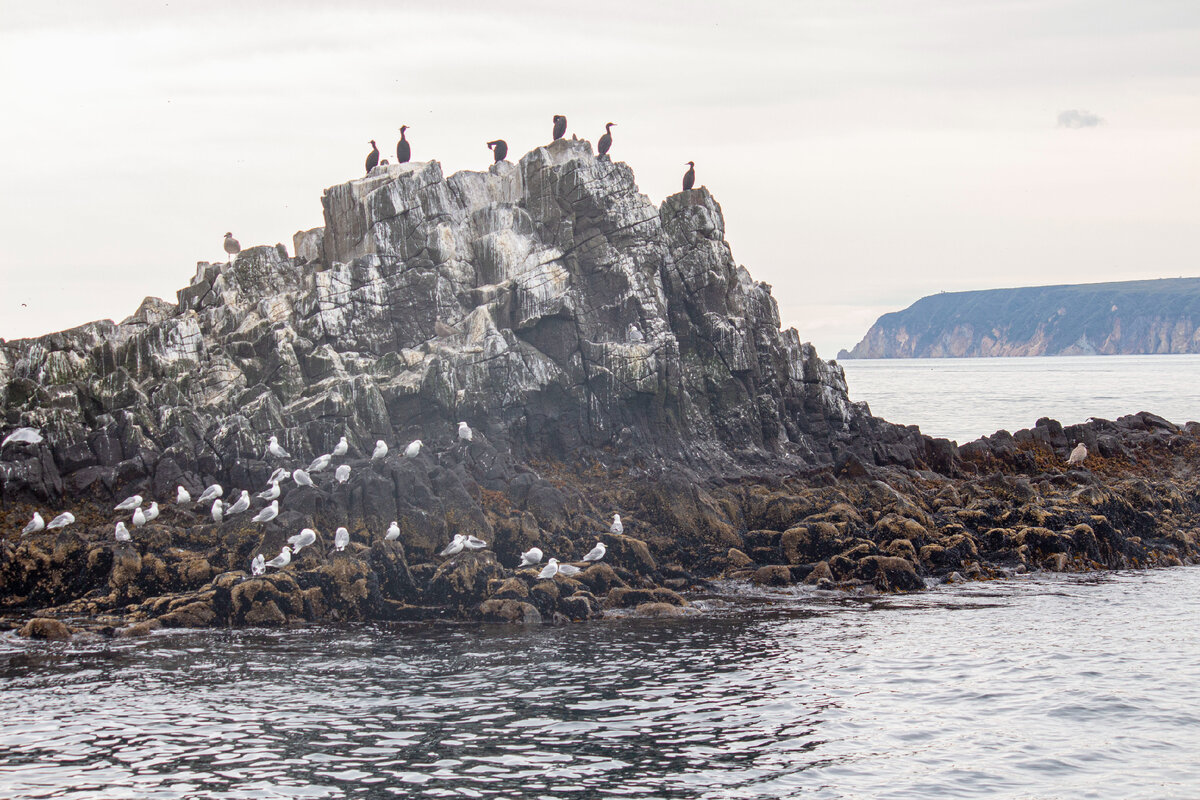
[0,139,1200,638]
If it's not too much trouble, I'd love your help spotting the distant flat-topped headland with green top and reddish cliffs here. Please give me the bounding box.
[838,278,1200,359]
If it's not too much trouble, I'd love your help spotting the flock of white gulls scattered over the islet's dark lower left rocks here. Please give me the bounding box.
[9,422,624,578]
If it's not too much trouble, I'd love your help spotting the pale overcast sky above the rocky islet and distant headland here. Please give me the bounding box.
[0,0,1200,359]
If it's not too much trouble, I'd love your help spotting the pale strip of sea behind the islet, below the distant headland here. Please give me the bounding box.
[839,355,1200,443]
